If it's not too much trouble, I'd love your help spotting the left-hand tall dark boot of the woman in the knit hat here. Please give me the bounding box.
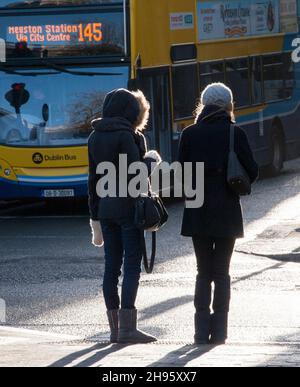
[195,275,212,345]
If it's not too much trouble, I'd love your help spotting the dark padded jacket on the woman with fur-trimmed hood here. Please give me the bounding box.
[88,118,149,220]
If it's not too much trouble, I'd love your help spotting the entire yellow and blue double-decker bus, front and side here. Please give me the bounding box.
[0,0,300,200]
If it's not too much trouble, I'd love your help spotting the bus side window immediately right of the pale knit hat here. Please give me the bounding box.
[225,58,250,107]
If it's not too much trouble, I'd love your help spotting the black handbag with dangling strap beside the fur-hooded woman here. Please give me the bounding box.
[134,192,169,274]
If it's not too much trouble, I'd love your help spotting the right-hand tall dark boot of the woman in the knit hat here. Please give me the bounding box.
[210,276,231,345]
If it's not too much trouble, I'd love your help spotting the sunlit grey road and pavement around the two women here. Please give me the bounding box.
[0,160,300,367]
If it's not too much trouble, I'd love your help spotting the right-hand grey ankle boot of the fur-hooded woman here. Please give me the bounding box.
[118,309,157,344]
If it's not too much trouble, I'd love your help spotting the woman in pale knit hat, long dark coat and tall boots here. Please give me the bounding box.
[179,83,258,344]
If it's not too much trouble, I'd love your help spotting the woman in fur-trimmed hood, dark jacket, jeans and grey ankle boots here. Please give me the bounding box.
[88,89,160,343]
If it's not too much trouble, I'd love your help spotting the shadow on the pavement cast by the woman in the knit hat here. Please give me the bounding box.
[147,345,216,367]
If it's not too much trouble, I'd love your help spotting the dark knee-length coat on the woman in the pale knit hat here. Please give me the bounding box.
[179,106,258,238]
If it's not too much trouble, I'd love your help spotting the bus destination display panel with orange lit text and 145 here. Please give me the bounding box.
[0,11,125,59]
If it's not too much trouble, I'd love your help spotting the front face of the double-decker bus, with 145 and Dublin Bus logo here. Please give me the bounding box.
[0,0,131,199]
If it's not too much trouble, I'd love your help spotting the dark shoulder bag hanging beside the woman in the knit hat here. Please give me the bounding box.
[227,125,251,196]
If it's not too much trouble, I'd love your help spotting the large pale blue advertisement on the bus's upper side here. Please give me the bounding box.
[197,0,298,41]
